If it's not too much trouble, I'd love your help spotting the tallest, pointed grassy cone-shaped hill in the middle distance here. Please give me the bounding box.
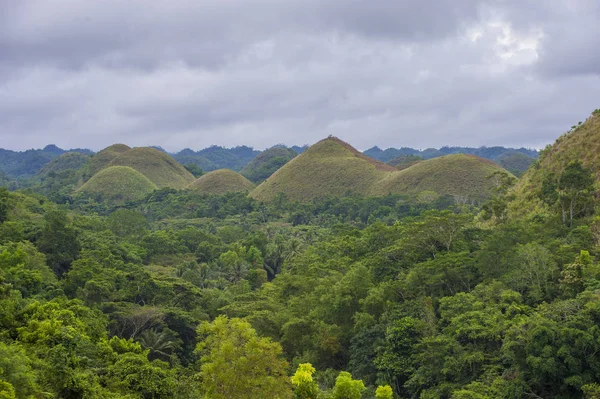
[251,137,396,201]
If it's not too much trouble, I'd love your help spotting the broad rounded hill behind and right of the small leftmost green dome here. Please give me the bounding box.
[109,147,194,189]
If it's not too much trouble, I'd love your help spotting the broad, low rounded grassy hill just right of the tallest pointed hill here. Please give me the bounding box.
[371,154,505,201]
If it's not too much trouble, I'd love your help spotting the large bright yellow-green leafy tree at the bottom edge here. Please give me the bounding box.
[196,316,292,399]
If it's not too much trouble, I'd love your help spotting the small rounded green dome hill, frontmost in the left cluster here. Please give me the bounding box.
[77,166,157,203]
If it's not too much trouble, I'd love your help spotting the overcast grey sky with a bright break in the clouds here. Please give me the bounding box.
[0,0,600,151]
